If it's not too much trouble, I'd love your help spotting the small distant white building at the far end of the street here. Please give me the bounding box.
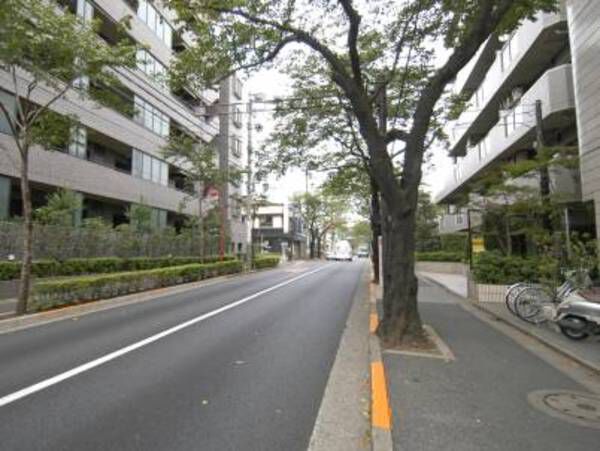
[252,203,306,258]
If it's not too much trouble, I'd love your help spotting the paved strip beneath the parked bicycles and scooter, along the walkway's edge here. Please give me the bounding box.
[419,273,600,374]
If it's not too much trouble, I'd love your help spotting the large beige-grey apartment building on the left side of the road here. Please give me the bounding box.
[0,0,245,251]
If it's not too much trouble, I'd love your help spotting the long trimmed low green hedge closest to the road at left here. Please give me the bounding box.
[28,260,242,312]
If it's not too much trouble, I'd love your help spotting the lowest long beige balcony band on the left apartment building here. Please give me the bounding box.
[0,134,198,215]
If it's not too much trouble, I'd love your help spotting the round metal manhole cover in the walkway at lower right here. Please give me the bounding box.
[527,390,600,429]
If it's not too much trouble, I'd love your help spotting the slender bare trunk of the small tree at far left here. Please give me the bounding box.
[17,147,33,315]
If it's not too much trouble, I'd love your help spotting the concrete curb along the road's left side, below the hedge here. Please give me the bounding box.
[0,266,282,335]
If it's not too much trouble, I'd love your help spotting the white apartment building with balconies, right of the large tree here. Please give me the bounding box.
[434,1,600,247]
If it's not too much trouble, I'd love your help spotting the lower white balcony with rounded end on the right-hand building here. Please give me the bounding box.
[435,64,575,202]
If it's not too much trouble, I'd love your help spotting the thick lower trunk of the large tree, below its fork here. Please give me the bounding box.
[377,200,424,346]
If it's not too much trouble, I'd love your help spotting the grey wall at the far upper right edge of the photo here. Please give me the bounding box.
[567,0,600,236]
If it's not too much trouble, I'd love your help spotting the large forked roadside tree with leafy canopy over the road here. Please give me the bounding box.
[167,0,557,345]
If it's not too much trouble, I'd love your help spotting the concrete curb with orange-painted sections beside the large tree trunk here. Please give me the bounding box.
[369,284,393,451]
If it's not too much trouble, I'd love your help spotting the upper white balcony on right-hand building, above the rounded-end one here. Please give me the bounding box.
[449,7,568,156]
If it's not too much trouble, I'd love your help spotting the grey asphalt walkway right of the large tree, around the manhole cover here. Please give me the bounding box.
[384,281,598,451]
